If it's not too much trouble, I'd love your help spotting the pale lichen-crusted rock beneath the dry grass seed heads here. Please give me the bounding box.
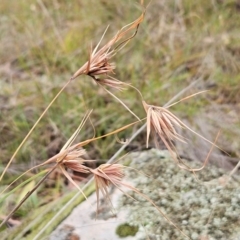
[50,149,240,240]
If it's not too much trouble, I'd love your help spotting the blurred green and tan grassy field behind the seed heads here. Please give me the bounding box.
[0,0,240,234]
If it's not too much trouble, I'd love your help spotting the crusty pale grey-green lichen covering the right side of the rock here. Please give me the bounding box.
[121,149,240,240]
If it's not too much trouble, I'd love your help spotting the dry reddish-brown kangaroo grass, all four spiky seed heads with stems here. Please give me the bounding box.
[0,1,230,239]
